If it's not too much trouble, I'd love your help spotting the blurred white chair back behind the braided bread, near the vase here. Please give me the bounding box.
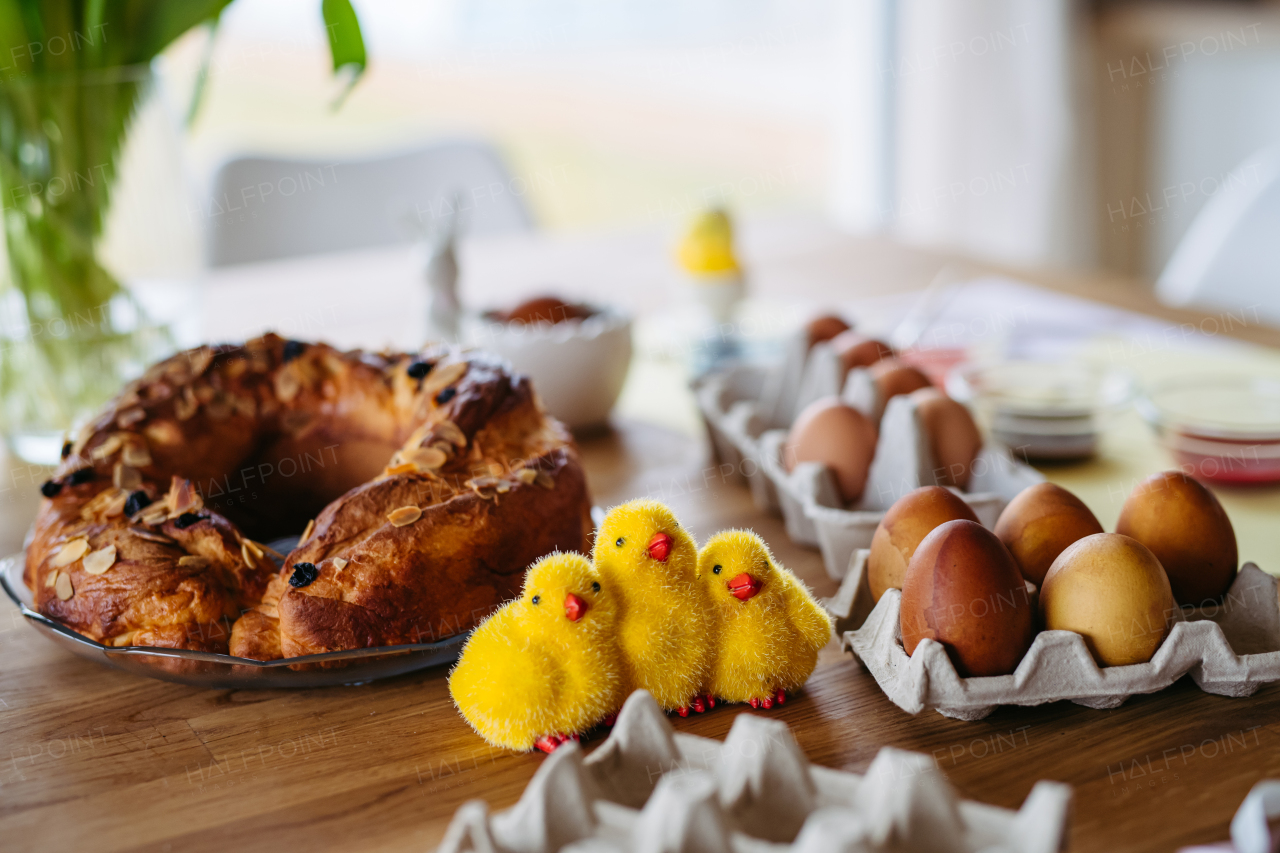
[201,141,534,266]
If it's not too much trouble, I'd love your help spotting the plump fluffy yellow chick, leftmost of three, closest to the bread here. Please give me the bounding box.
[449,553,626,752]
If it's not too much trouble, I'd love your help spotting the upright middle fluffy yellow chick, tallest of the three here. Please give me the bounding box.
[593,500,712,716]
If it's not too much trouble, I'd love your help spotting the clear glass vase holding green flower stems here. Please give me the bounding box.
[0,67,189,464]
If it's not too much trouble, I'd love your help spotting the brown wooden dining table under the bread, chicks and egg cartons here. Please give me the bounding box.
[0,224,1280,852]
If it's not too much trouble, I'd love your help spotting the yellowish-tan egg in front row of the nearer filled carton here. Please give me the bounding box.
[1039,533,1178,666]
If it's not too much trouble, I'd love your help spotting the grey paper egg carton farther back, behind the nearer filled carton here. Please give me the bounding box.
[698,338,1044,580]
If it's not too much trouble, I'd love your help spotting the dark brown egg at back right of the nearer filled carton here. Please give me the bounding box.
[1116,471,1239,607]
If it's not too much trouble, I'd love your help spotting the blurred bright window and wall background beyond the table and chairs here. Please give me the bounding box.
[127,0,1280,284]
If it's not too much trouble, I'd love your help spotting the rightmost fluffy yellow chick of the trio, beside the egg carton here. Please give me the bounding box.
[698,530,832,708]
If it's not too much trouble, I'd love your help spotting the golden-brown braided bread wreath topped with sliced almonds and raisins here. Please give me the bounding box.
[26,334,590,660]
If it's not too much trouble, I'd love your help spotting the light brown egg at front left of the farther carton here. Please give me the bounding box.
[782,397,876,503]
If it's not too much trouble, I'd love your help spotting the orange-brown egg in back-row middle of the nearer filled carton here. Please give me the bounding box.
[996,483,1102,585]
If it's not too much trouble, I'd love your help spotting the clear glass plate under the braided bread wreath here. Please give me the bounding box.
[0,540,467,689]
